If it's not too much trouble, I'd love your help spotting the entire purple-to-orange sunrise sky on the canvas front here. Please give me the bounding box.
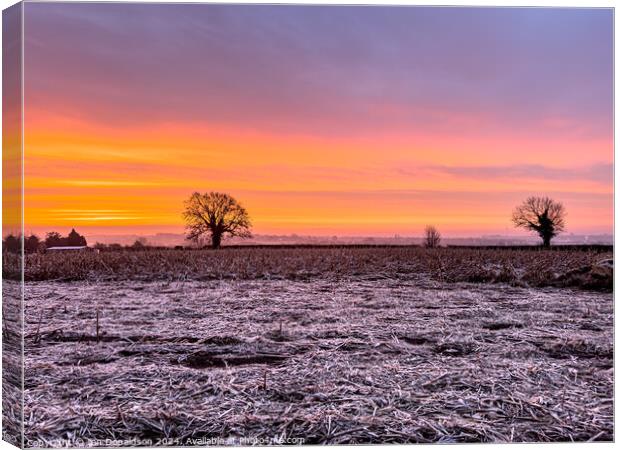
[19,3,613,236]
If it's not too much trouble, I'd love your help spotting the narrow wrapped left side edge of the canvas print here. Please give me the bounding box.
[2,2,25,448]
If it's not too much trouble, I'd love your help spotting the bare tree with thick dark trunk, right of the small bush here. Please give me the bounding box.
[512,197,566,247]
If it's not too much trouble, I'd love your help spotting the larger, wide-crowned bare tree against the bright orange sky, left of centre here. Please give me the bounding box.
[183,192,252,248]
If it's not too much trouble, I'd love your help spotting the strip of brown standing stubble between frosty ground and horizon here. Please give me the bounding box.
[8,247,613,290]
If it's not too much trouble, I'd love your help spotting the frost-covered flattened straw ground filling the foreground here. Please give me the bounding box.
[20,277,613,446]
